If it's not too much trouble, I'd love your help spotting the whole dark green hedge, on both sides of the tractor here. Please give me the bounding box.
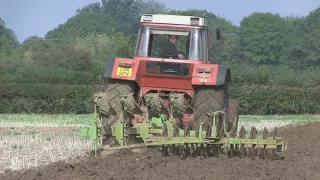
[0,84,320,115]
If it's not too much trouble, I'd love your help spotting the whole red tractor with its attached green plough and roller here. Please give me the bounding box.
[80,14,286,158]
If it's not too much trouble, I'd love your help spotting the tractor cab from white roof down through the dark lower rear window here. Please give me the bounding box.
[134,14,220,76]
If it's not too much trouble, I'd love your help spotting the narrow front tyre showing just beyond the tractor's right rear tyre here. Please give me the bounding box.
[227,99,239,132]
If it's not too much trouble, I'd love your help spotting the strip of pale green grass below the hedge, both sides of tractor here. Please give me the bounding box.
[0,114,320,127]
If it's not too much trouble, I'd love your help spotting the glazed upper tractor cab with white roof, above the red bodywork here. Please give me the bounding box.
[134,14,214,62]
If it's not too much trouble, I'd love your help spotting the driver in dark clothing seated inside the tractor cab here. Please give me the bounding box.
[160,35,186,59]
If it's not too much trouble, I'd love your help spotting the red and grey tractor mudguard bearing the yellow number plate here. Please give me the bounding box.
[104,58,139,81]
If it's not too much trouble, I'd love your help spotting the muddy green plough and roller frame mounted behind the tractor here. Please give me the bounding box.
[80,93,287,158]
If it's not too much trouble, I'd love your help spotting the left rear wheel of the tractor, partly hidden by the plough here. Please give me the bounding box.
[98,80,137,145]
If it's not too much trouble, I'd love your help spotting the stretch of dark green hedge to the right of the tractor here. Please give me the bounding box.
[230,85,320,115]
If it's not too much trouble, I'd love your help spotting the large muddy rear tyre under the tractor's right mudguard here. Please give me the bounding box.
[193,84,229,134]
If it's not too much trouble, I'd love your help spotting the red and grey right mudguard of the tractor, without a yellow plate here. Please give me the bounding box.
[192,64,231,86]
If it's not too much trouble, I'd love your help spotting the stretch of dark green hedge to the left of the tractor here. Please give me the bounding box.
[0,84,99,114]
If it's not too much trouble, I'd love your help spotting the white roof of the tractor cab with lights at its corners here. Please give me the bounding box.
[140,14,207,26]
